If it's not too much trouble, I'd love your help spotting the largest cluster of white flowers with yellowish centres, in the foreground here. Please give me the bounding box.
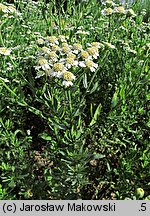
[35,35,100,86]
